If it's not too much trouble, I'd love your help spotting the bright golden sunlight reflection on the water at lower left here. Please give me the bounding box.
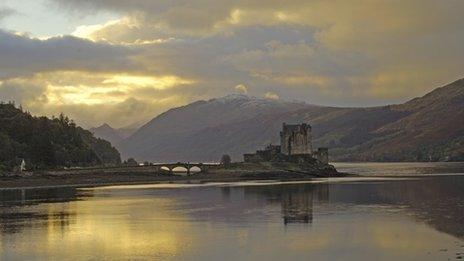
[39,199,189,257]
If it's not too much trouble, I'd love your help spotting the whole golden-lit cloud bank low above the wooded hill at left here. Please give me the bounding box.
[0,71,192,127]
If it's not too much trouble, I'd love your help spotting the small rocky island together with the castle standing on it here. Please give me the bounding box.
[200,123,340,179]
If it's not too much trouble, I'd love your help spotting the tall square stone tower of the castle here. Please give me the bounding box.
[280,123,313,155]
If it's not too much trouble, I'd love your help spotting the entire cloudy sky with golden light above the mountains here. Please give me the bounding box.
[0,0,464,127]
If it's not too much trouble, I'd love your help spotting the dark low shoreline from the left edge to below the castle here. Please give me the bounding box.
[0,166,346,190]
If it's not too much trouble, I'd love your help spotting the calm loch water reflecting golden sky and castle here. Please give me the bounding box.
[0,163,464,260]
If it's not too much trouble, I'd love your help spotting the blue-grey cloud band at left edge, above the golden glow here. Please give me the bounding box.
[0,30,137,78]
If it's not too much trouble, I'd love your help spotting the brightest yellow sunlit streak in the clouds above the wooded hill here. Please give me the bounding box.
[18,71,194,106]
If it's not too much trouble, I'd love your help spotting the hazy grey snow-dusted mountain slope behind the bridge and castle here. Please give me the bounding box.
[119,95,308,161]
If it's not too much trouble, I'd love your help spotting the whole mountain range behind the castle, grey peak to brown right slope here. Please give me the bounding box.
[94,79,464,162]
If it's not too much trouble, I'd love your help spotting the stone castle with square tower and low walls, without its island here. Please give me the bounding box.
[243,123,329,164]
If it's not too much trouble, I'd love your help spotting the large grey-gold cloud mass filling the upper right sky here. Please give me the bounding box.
[55,0,464,99]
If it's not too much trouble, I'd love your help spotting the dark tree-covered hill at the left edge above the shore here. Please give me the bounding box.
[0,103,121,171]
